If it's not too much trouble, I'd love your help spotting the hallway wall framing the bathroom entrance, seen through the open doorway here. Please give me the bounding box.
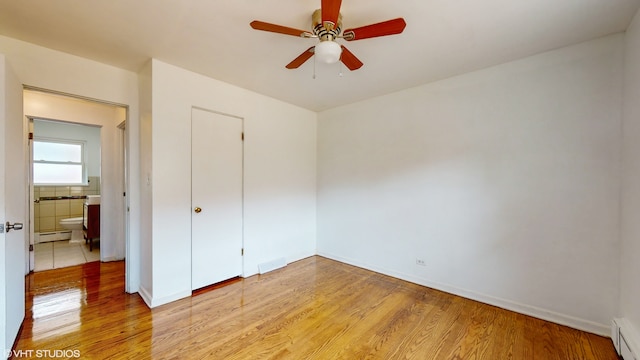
[24,91,125,261]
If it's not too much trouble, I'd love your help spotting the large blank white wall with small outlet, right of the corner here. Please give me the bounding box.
[318,35,623,334]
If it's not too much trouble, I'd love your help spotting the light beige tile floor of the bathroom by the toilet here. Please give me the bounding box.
[34,240,100,271]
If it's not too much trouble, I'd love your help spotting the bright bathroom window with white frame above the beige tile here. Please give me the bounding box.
[33,138,88,185]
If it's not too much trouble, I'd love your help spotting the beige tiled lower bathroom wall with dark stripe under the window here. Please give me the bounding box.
[33,176,100,233]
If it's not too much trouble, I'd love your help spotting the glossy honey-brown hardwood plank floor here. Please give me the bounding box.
[15,257,617,360]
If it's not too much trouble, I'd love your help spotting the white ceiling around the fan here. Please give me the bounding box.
[0,0,640,111]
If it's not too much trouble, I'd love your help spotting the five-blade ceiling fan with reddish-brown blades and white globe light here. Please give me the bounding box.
[250,0,407,71]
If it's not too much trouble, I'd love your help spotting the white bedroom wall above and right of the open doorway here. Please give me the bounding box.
[0,36,140,292]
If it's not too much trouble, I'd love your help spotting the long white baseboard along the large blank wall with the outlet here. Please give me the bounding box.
[318,252,611,337]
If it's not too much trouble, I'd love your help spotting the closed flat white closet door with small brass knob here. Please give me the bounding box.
[191,108,243,290]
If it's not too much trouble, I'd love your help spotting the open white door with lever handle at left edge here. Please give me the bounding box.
[0,55,28,357]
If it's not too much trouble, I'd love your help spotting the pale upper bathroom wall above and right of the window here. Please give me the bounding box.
[33,119,100,176]
